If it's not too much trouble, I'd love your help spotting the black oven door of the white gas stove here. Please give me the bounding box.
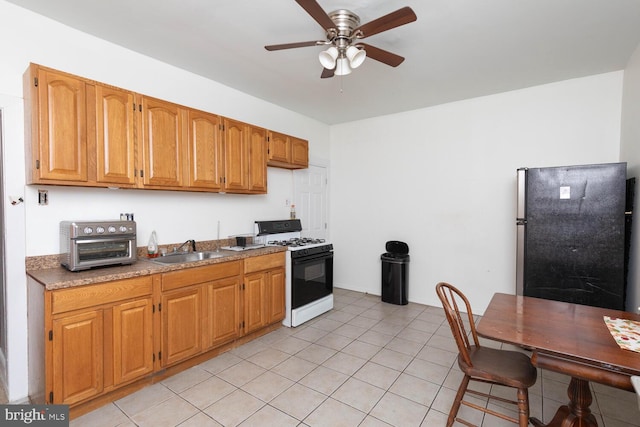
[291,252,333,309]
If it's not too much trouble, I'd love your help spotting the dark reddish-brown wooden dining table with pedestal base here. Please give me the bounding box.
[477,293,640,427]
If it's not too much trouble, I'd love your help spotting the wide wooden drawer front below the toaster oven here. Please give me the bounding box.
[51,276,153,314]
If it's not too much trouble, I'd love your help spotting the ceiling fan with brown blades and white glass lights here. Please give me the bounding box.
[264,0,418,79]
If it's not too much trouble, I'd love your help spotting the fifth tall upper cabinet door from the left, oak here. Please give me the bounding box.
[224,119,249,190]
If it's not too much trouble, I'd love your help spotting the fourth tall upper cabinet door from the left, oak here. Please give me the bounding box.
[189,110,224,190]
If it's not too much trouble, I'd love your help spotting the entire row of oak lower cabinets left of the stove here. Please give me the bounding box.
[28,252,285,414]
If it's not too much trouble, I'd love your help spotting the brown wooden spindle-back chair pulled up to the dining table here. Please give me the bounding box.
[436,282,537,427]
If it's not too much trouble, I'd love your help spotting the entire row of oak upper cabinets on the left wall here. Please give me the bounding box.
[24,64,308,194]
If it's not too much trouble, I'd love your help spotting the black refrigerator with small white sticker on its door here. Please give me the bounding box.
[516,163,633,310]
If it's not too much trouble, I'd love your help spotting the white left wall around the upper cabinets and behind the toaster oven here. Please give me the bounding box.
[0,0,329,401]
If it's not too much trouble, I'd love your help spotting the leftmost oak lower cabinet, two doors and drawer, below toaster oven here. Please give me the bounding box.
[44,276,154,405]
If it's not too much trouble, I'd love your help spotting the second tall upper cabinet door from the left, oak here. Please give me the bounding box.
[95,85,135,186]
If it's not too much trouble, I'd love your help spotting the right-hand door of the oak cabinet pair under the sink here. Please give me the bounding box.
[207,277,240,348]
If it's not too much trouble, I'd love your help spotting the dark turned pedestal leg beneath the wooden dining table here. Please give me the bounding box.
[530,377,598,427]
